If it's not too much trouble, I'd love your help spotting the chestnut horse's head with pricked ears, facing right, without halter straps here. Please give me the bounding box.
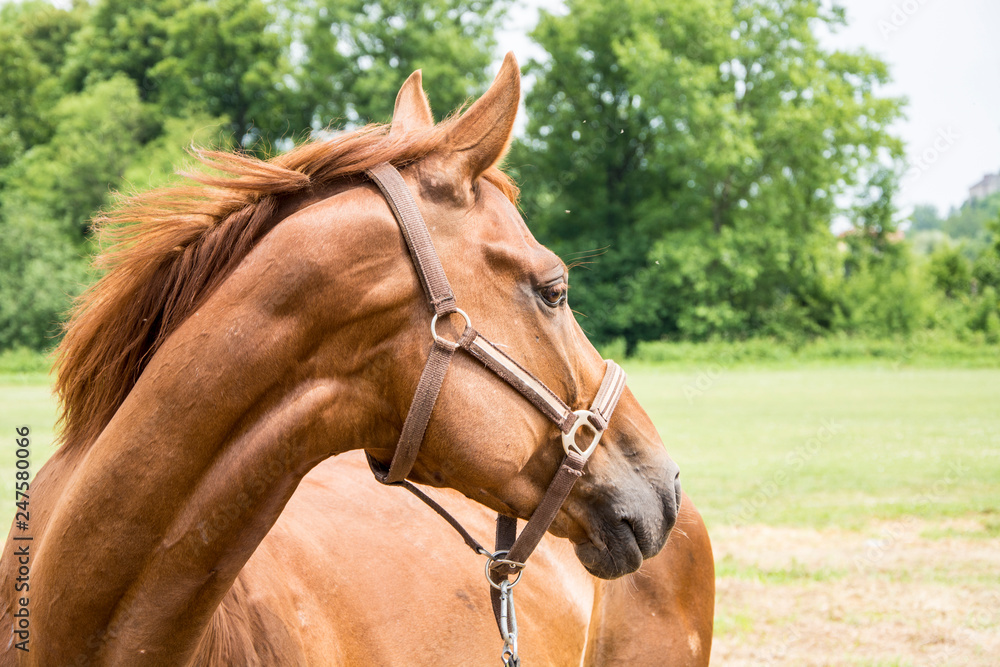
[356,55,681,578]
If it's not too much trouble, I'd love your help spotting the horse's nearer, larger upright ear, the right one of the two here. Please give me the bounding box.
[446,52,521,180]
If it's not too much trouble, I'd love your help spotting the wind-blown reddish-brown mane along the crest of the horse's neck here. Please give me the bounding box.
[55,116,517,448]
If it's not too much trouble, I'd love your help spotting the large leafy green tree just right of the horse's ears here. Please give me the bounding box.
[512,0,902,350]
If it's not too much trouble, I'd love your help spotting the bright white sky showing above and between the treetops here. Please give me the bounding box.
[498,0,1000,215]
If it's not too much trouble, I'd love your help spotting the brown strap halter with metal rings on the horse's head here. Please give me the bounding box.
[367,162,625,665]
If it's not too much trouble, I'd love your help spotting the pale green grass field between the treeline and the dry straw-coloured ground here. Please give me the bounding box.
[0,364,1000,531]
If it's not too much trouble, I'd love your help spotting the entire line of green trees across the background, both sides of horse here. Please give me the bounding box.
[0,0,1000,350]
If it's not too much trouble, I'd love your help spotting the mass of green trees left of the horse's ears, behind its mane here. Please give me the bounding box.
[0,0,509,348]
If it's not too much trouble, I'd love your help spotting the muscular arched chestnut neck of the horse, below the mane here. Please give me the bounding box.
[20,190,419,664]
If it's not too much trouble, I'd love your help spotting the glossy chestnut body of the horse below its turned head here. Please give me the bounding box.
[194,454,714,667]
